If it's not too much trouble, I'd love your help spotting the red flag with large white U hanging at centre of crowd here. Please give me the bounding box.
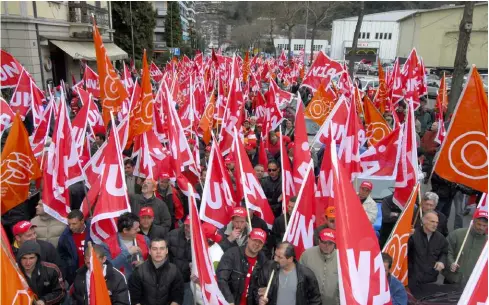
[200,141,236,228]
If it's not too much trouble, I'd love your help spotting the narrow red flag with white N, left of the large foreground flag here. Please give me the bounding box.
[284,161,315,259]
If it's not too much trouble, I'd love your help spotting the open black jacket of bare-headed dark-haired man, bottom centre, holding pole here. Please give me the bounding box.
[250,260,321,305]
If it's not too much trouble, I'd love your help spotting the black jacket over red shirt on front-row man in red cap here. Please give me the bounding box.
[216,245,266,305]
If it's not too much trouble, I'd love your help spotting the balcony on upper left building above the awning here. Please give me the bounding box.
[68,1,110,28]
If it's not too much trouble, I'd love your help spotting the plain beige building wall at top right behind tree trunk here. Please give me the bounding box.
[397,3,488,69]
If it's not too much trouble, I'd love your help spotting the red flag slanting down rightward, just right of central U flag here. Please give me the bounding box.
[234,129,275,229]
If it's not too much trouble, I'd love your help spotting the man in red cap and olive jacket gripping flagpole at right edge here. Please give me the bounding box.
[443,211,487,285]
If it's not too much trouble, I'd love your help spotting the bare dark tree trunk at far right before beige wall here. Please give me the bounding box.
[448,2,474,115]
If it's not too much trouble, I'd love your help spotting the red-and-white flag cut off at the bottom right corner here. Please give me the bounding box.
[458,242,489,305]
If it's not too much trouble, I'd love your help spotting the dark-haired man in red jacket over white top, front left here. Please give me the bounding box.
[102,212,149,278]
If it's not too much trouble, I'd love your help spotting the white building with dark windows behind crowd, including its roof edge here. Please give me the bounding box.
[331,10,416,62]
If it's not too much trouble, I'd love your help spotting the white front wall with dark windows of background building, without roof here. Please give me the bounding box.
[331,19,399,61]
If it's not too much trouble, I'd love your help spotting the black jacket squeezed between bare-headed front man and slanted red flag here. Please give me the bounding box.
[166,226,192,283]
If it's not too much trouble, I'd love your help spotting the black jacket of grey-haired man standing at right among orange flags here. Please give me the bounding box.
[408,227,450,289]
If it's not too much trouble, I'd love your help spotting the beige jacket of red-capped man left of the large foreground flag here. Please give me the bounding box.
[300,246,340,305]
